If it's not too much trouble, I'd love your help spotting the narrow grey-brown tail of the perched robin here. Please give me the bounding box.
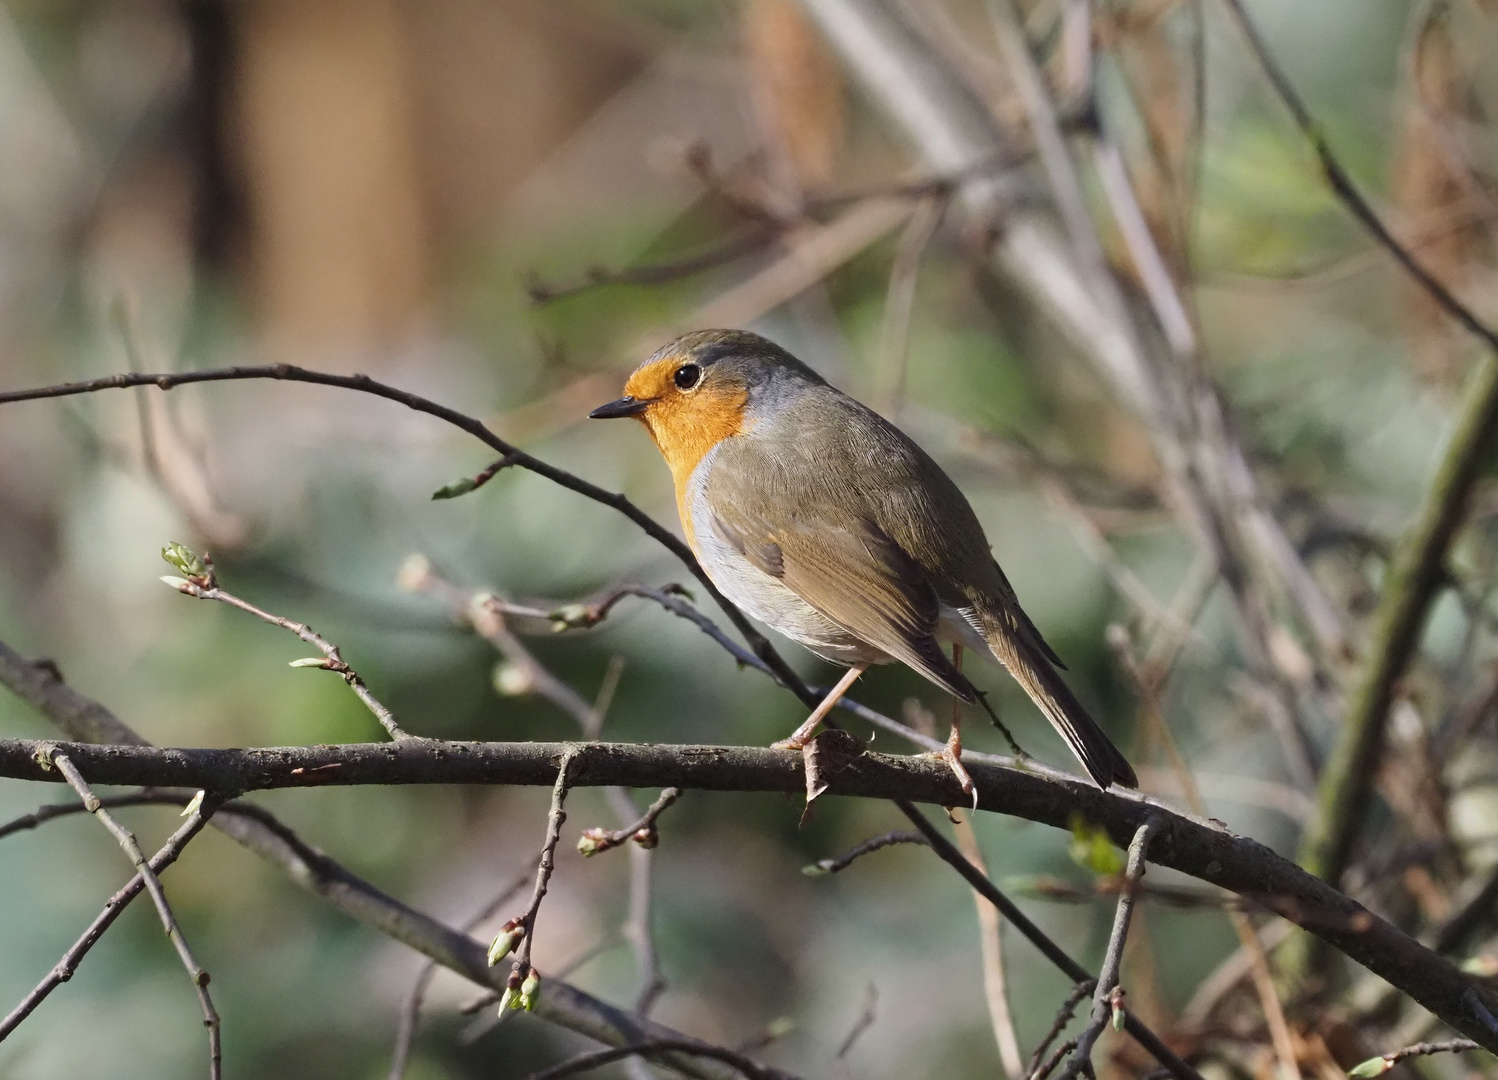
[983,613,1138,789]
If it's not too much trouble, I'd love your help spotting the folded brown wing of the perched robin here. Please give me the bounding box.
[709,458,975,701]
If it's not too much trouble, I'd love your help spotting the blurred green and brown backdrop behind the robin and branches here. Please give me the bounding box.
[0,0,1498,1080]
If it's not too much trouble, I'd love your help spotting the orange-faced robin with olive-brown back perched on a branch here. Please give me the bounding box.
[589,330,1138,794]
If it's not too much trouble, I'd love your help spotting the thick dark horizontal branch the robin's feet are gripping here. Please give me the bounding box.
[0,740,1498,1049]
